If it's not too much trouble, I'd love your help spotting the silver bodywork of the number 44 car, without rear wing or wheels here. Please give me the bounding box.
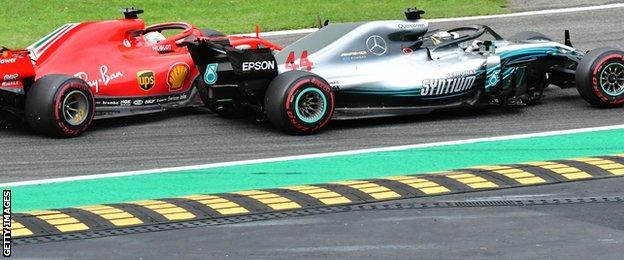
[275,20,583,119]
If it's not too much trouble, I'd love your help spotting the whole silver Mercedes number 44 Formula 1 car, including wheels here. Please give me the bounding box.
[187,9,624,134]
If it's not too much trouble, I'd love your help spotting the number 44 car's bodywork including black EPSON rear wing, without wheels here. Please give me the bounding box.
[189,12,585,123]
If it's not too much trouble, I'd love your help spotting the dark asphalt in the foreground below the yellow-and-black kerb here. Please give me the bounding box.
[13,177,624,259]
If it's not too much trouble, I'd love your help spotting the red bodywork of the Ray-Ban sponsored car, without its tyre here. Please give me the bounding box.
[0,11,281,118]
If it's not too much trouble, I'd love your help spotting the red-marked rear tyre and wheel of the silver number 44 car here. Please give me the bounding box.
[264,71,334,134]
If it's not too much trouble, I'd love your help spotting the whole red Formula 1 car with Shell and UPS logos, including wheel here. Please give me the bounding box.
[0,8,281,137]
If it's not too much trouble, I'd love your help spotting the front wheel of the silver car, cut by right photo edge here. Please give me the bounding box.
[575,48,624,108]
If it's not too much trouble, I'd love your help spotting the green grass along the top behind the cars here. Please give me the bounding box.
[0,0,507,48]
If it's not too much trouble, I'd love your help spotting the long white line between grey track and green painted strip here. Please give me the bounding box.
[0,124,624,188]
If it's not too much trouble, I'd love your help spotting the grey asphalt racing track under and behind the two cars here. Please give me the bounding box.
[0,8,624,182]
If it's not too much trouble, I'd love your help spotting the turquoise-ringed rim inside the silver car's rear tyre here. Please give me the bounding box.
[295,88,327,123]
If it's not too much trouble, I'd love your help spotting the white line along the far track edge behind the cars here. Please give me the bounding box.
[238,3,624,37]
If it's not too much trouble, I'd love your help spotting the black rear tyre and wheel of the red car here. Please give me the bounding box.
[26,74,95,137]
